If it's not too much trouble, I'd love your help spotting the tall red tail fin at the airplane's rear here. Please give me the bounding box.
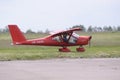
[8,25,26,44]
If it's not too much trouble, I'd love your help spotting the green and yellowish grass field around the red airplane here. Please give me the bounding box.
[0,32,120,60]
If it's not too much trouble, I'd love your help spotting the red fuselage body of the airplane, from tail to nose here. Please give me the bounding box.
[16,36,91,46]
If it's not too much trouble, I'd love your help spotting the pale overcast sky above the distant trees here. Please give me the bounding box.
[0,0,120,31]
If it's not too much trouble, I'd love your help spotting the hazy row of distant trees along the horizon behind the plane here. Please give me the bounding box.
[0,25,120,33]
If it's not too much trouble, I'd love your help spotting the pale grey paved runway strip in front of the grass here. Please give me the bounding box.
[0,58,120,80]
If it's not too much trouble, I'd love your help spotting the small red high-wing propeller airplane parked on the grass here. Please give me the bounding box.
[8,25,92,52]
